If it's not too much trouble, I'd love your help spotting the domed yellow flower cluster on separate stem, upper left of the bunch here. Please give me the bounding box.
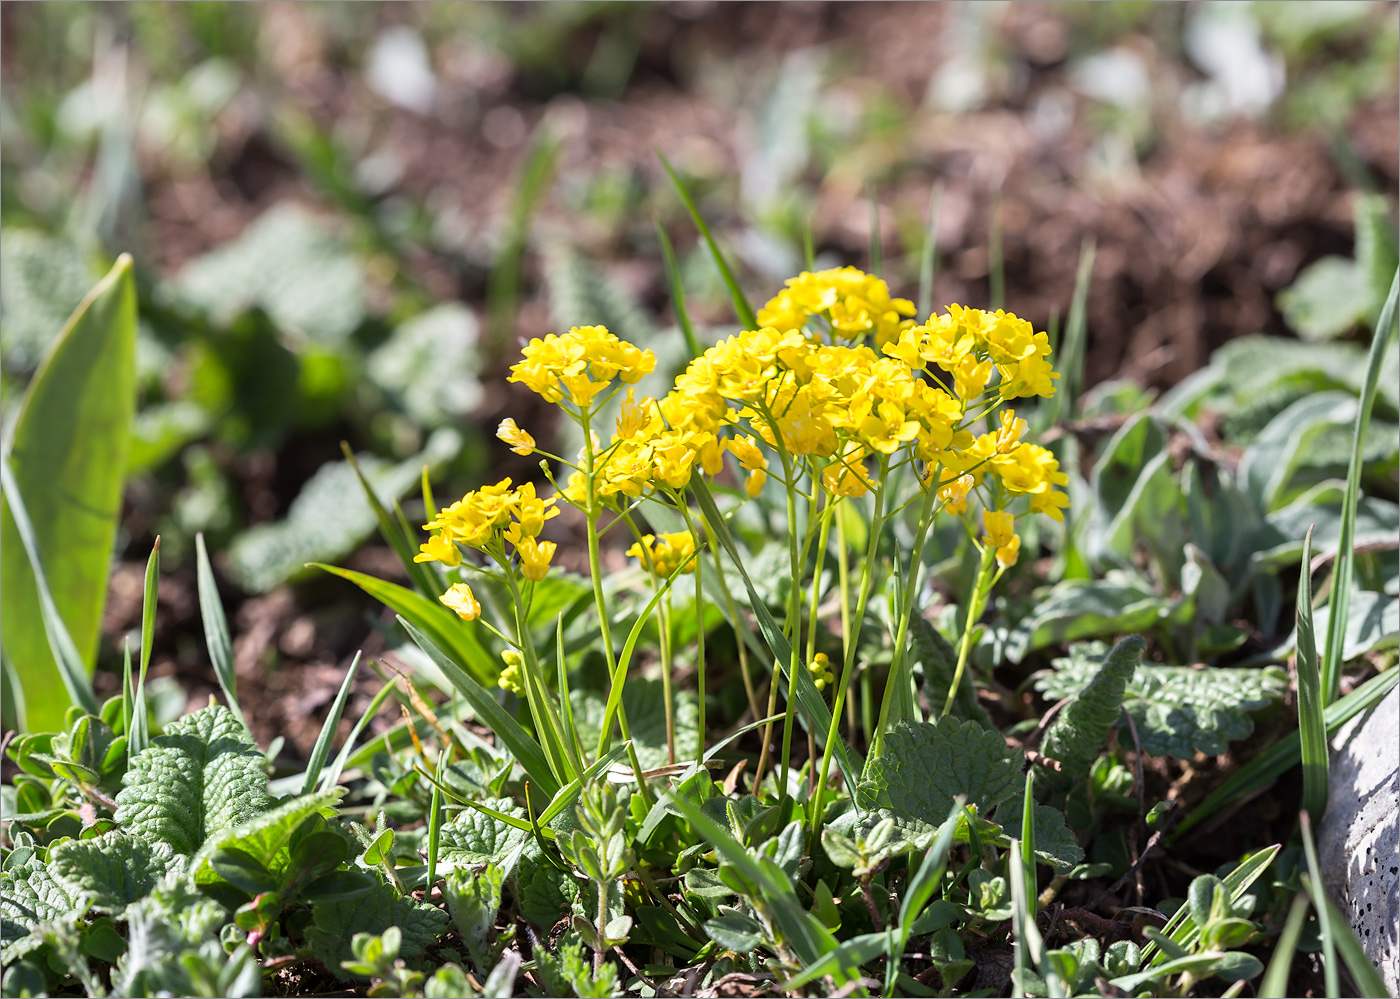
[507,326,657,407]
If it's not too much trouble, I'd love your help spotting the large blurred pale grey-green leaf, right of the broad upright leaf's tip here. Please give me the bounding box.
[172,204,365,344]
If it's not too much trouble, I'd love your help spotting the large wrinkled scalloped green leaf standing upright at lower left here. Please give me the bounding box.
[116,704,269,856]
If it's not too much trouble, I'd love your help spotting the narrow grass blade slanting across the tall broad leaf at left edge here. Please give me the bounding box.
[0,455,98,730]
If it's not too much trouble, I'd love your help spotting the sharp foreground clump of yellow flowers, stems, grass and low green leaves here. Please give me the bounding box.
[0,180,1396,996]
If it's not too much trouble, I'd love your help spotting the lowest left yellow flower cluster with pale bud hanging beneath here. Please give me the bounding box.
[413,479,559,598]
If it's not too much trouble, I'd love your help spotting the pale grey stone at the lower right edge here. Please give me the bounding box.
[1317,688,1400,996]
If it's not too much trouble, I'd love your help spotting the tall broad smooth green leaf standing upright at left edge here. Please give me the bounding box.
[0,256,136,732]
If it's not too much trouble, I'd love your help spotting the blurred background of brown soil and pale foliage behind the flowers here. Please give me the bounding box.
[0,0,1400,742]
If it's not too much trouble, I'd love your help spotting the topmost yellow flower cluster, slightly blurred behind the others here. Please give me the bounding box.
[759,267,914,347]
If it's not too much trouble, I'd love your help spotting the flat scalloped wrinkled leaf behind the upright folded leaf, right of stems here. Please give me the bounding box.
[1036,642,1288,760]
